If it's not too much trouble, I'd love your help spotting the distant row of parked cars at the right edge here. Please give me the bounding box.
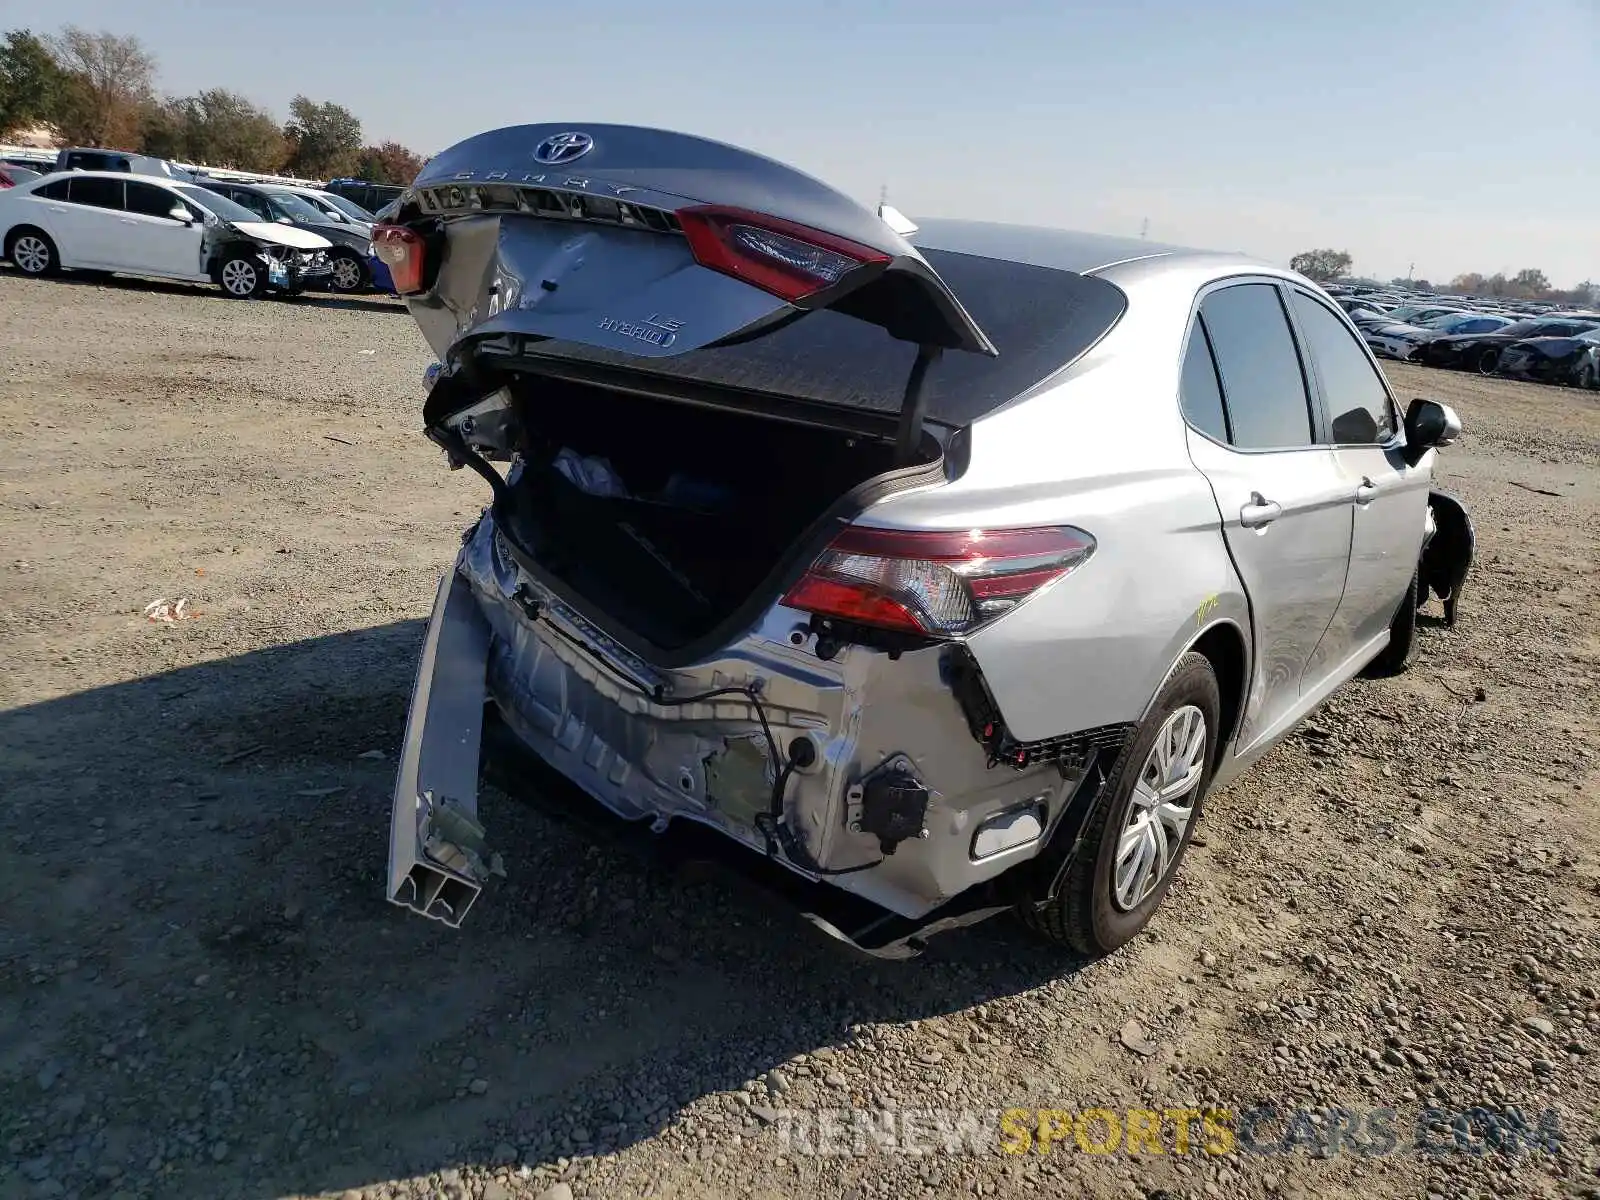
[1331,288,1600,389]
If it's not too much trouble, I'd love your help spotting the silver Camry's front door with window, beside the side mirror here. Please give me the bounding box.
[1290,288,1432,672]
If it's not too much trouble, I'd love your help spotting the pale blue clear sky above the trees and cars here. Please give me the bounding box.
[12,0,1600,286]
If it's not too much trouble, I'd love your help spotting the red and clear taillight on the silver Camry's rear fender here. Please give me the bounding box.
[784,525,1094,637]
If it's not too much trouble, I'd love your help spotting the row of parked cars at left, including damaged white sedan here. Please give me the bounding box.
[0,150,400,298]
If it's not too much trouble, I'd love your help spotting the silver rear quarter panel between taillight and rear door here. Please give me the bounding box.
[866,262,1250,741]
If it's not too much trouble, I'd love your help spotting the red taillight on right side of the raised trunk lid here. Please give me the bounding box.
[677,205,890,301]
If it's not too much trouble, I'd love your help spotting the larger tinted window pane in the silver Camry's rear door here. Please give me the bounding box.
[1200,283,1314,450]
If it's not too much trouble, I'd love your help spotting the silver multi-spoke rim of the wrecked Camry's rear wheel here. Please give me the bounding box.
[1110,704,1208,912]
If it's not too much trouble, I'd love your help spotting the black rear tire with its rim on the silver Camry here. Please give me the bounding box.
[1016,654,1222,957]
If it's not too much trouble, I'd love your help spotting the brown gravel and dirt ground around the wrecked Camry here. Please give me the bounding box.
[0,274,1600,1200]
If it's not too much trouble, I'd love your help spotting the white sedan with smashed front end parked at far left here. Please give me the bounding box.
[0,171,331,299]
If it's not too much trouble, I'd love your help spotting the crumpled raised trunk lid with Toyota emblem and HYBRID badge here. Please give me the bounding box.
[378,125,995,438]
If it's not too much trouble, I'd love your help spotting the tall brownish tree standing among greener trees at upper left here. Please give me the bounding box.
[50,26,155,147]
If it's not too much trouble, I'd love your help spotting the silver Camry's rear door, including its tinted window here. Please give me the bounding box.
[1182,280,1352,749]
